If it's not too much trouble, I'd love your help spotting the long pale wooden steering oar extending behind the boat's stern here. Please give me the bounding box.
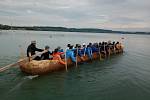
[0,50,47,72]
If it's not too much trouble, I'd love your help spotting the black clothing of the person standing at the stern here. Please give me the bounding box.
[27,44,44,60]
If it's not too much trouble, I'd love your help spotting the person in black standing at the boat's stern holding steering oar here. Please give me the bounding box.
[27,41,44,61]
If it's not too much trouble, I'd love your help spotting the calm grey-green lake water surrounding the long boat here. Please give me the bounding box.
[0,31,150,100]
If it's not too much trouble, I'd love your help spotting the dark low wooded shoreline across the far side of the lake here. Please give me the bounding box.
[0,24,150,35]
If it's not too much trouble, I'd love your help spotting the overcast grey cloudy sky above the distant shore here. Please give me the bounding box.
[0,0,150,31]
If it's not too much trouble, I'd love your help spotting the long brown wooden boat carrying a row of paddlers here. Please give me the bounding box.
[19,49,123,75]
